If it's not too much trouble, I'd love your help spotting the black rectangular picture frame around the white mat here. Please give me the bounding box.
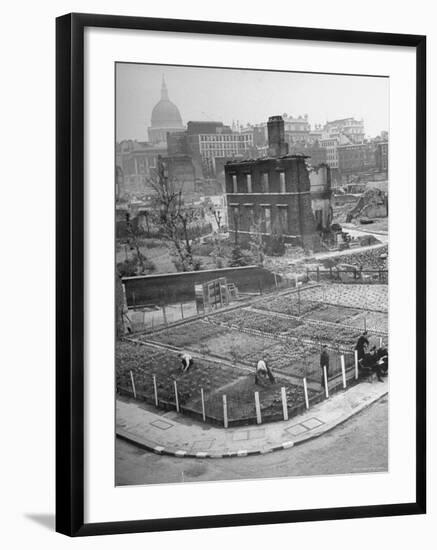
[56,14,426,536]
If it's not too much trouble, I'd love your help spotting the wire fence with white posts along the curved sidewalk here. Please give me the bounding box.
[116,355,358,428]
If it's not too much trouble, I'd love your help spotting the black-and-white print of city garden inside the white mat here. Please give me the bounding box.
[114,61,390,486]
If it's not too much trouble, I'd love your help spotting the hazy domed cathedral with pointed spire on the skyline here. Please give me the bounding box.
[148,77,184,144]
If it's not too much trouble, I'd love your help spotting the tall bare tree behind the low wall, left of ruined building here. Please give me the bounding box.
[149,157,200,271]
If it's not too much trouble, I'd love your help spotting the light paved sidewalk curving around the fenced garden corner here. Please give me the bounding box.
[116,379,388,458]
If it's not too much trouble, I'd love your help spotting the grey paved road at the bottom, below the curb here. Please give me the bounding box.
[116,397,388,485]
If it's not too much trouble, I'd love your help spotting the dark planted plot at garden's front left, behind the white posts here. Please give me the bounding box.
[115,341,242,405]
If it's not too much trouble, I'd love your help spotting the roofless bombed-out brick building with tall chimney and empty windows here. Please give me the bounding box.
[225,116,332,250]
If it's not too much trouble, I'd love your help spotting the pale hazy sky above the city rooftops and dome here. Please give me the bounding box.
[116,63,389,141]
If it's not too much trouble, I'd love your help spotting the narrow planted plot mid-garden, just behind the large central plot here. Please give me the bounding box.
[214,309,300,335]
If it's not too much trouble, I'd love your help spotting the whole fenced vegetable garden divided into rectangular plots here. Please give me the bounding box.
[116,281,388,427]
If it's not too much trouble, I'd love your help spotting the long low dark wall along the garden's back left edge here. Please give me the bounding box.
[122,266,281,307]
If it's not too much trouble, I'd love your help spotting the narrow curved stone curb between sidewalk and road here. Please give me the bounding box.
[116,390,388,458]
